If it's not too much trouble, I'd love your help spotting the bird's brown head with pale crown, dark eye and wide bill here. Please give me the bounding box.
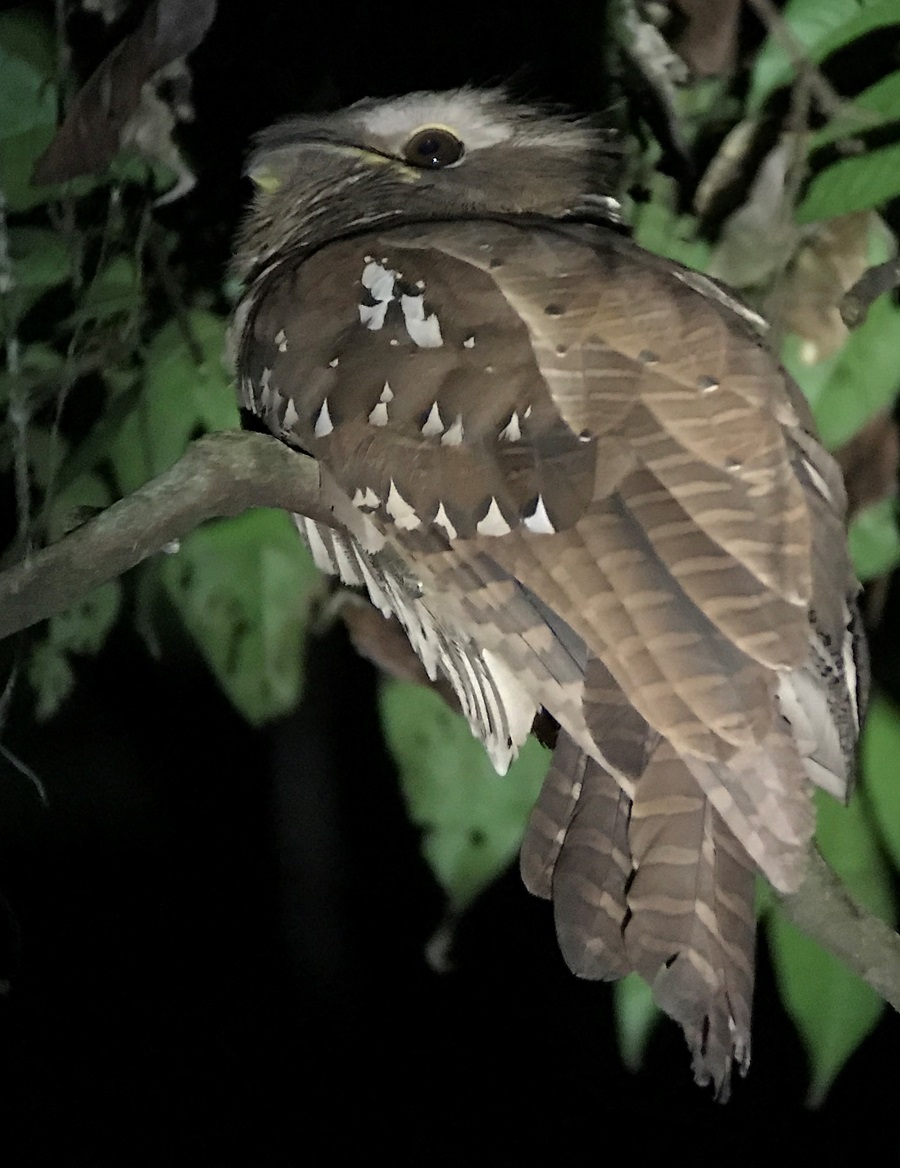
[238,89,622,273]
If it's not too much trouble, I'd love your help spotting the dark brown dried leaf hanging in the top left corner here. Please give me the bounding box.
[33,0,217,183]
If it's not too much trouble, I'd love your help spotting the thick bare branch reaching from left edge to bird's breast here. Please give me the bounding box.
[0,430,333,639]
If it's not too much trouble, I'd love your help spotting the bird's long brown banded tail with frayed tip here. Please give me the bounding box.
[522,731,755,1100]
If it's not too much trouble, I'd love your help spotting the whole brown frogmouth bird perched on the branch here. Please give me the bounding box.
[235,89,865,1098]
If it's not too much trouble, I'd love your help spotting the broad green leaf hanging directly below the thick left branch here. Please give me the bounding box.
[161,509,321,723]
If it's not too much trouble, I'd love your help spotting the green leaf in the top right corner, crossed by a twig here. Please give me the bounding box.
[748,0,900,110]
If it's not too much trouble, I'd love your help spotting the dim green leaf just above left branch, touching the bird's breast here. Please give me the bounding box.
[112,310,240,494]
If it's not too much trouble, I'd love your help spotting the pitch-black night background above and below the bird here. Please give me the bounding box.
[0,0,900,1168]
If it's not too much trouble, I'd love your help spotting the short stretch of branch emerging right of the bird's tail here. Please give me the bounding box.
[779,848,900,1011]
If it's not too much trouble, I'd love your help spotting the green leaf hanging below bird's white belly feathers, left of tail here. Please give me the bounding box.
[381,681,550,911]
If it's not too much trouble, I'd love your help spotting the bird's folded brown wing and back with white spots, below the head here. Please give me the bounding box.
[235,222,853,888]
